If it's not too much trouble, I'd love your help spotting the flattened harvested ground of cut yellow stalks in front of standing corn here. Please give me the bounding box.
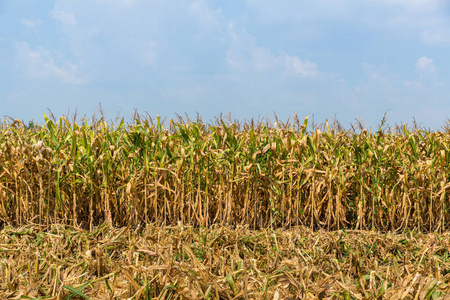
[0,225,450,299]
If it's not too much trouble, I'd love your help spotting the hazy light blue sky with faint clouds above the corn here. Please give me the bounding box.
[0,0,450,129]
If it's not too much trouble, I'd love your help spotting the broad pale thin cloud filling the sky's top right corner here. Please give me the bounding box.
[244,0,450,47]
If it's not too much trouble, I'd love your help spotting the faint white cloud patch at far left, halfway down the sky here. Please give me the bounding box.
[15,42,85,84]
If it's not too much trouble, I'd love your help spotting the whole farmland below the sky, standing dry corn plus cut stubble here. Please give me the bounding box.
[0,115,450,299]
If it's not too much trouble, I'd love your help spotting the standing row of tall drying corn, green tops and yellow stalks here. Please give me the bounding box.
[0,115,450,232]
